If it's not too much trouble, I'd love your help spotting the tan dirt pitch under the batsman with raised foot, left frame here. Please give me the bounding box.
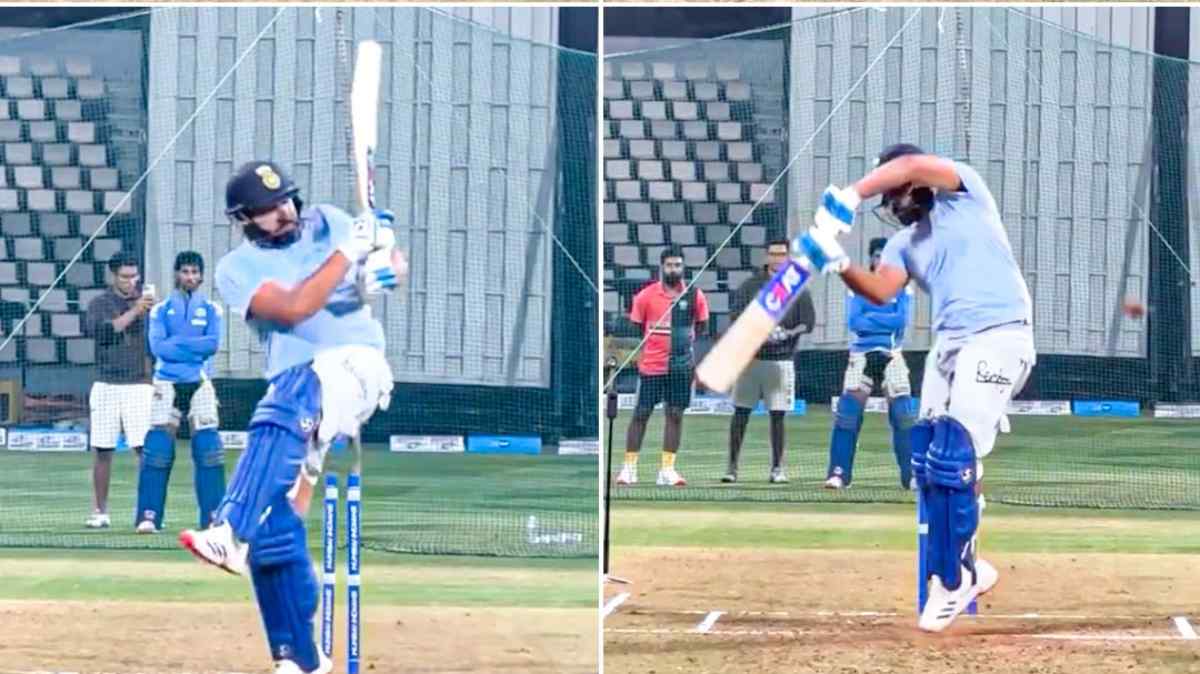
[0,601,596,674]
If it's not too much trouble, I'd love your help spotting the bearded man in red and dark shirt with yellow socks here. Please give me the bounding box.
[617,246,708,487]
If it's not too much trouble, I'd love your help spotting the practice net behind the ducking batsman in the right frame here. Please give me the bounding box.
[604,7,1200,508]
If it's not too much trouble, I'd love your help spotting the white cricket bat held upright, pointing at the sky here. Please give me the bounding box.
[350,40,383,215]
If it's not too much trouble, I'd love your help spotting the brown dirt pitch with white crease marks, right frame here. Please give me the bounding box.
[604,547,1200,674]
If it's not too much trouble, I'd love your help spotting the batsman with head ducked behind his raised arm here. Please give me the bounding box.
[793,144,1037,632]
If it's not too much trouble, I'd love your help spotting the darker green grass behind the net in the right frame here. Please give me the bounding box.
[613,405,1200,510]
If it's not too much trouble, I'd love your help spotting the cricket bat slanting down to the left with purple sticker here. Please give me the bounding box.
[696,258,812,393]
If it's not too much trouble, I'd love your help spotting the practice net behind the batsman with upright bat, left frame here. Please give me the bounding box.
[0,7,599,556]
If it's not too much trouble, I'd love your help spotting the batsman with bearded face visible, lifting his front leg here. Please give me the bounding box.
[180,161,407,674]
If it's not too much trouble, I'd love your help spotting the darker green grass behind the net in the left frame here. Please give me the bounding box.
[0,441,598,558]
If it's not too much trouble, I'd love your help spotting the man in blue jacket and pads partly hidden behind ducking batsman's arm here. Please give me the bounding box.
[826,237,917,489]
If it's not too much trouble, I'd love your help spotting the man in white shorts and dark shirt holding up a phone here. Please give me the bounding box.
[84,252,155,529]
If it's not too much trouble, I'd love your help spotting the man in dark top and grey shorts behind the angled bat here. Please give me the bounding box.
[721,239,816,485]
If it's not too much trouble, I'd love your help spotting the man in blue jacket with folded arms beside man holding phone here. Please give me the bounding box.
[137,251,226,534]
